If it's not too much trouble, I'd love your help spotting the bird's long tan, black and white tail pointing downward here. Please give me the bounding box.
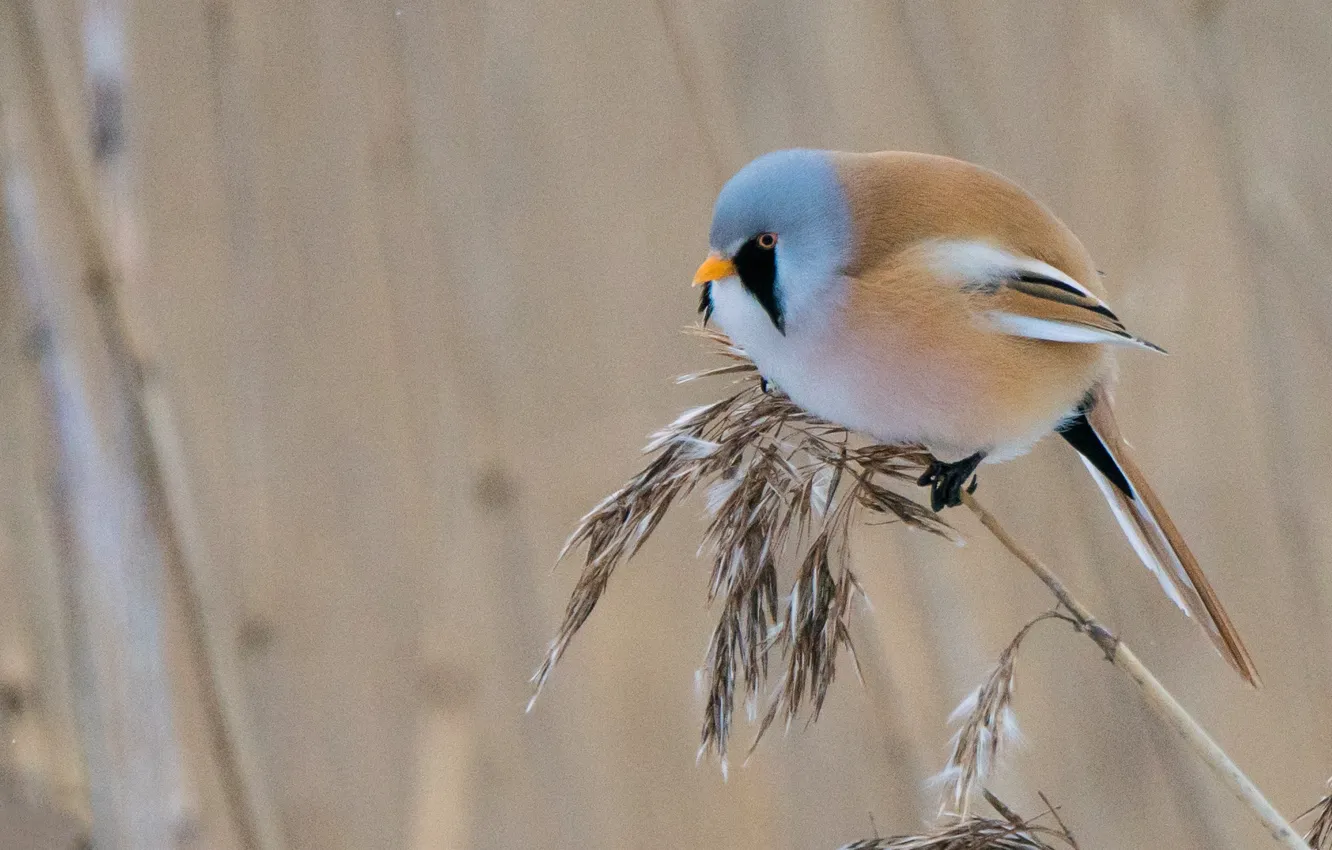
[1059,386,1260,687]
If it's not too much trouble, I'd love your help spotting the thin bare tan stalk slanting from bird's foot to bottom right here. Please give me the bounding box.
[962,493,1311,850]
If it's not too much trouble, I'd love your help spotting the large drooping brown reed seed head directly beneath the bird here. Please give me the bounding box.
[533,329,951,765]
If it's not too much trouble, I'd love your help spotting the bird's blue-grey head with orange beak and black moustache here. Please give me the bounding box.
[694,149,851,333]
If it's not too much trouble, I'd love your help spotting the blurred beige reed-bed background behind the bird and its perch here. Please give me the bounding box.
[0,0,1332,850]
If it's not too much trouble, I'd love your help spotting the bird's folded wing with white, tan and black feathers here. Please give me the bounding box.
[935,241,1164,353]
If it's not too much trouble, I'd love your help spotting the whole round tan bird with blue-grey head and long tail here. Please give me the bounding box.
[693,149,1259,687]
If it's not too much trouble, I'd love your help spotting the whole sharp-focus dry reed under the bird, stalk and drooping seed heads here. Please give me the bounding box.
[529,329,1309,850]
